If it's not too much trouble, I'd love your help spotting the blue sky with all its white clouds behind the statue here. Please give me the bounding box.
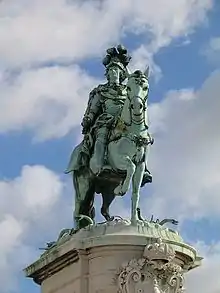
[0,0,220,293]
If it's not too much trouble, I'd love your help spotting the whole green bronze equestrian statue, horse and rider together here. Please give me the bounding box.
[66,45,153,229]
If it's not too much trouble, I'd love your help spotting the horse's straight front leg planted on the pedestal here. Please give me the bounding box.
[131,162,145,224]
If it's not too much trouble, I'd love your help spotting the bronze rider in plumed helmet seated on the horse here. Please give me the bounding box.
[82,45,131,174]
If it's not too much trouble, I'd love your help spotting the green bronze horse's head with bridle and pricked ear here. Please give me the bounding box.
[127,69,149,122]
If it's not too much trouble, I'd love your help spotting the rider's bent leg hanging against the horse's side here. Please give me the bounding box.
[90,127,108,174]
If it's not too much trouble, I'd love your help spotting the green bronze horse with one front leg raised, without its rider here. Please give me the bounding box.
[66,68,153,228]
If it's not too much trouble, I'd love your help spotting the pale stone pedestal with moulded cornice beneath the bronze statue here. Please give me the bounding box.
[25,220,202,293]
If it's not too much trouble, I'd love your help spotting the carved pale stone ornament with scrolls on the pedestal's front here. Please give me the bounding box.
[118,239,185,293]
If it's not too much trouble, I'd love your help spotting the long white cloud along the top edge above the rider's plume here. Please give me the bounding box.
[0,0,213,66]
